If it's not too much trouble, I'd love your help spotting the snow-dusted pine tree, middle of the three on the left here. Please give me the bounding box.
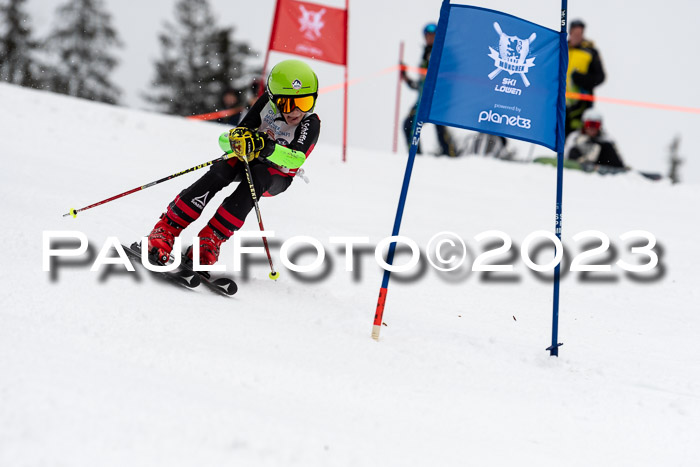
[46,0,122,104]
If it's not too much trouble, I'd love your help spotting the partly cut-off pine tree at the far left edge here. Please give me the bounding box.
[0,0,40,87]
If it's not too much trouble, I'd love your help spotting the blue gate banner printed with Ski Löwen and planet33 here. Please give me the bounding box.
[418,1,566,151]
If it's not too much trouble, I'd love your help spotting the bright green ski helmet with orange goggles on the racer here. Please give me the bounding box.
[267,60,318,113]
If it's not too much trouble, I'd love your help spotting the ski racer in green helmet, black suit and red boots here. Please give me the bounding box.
[148,60,321,265]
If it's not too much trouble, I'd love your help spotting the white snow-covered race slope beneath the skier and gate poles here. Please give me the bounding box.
[0,84,700,466]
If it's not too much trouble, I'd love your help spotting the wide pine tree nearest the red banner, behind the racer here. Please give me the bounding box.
[145,0,254,115]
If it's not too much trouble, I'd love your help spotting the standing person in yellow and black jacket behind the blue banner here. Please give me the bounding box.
[566,20,605,136]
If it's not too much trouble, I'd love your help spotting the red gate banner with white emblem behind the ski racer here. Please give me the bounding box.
[270,0,347,65]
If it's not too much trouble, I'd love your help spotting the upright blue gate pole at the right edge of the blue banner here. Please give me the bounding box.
[546,0,569,357]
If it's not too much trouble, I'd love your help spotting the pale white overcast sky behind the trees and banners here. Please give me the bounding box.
[27,0,700,183]
